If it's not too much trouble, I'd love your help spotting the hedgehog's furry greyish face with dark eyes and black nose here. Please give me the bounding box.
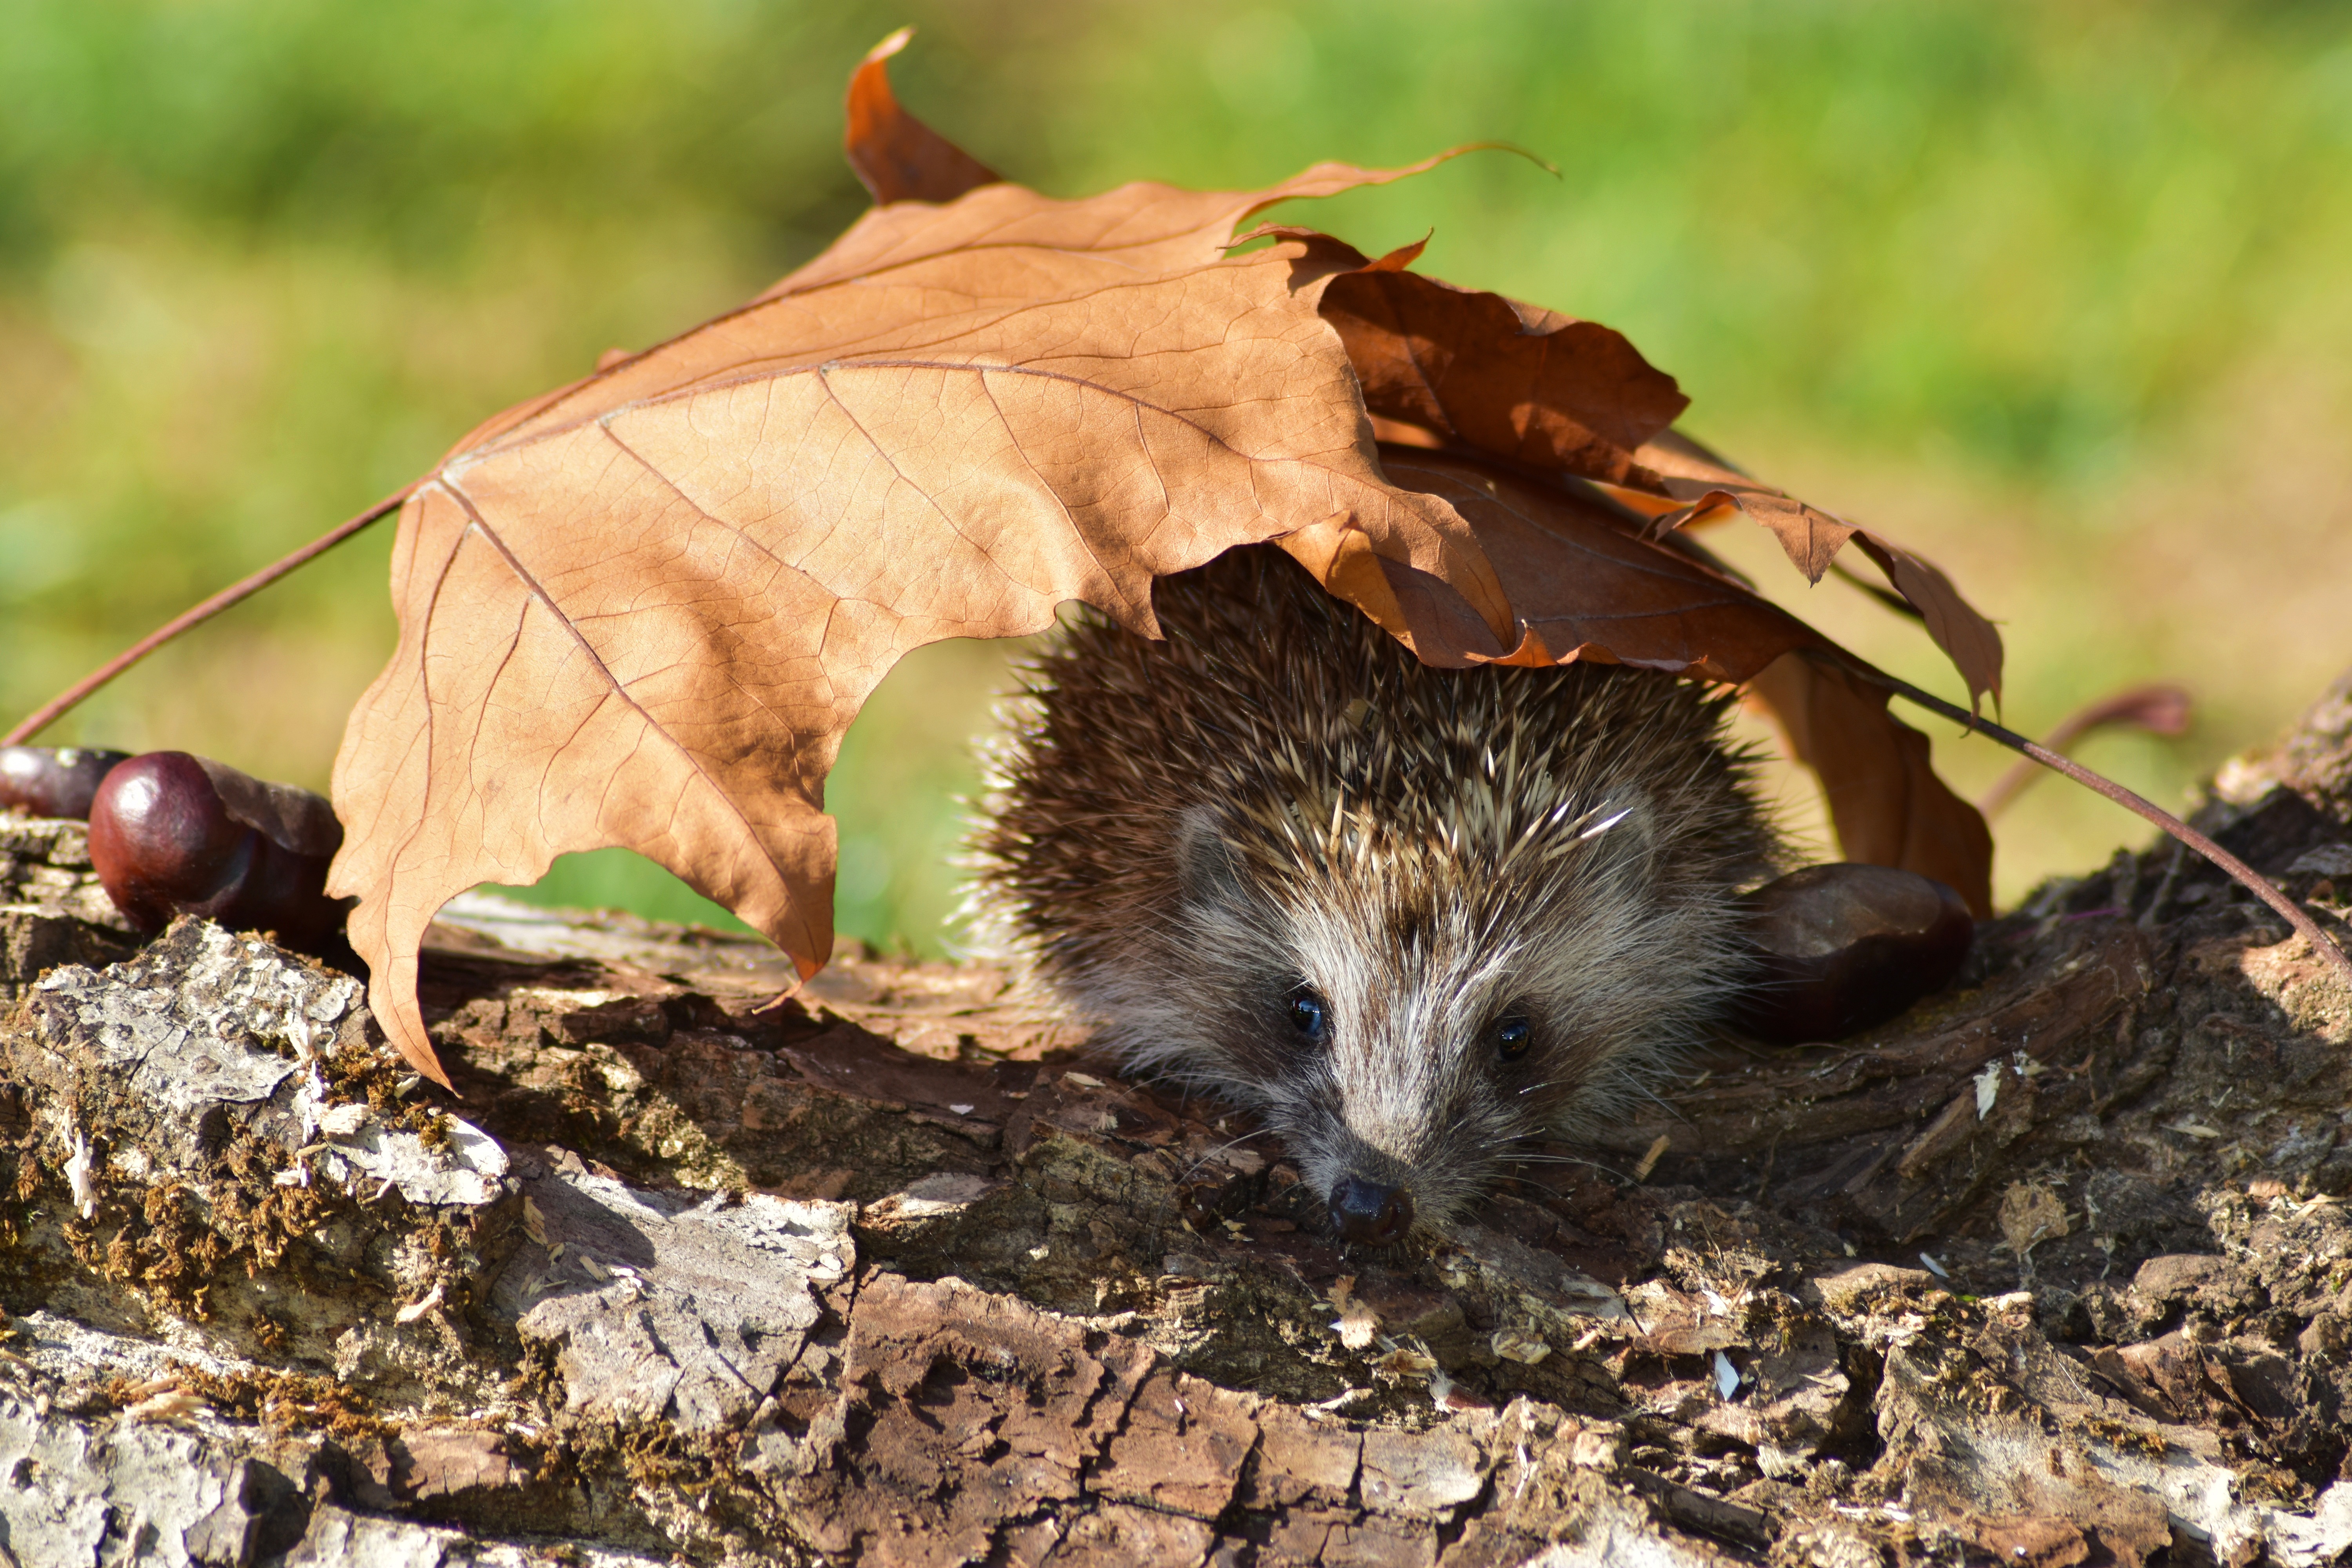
[1152,797,1722,1246]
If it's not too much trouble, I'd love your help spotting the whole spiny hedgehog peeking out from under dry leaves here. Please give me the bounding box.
[971,545,1780,1246]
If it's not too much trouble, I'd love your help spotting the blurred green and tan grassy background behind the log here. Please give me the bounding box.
[0,0,2352,952]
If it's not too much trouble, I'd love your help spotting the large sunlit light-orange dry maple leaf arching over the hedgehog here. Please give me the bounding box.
[334,202,1512,1086]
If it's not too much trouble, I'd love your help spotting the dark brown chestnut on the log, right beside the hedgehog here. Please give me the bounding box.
[1733,863,1976,1044]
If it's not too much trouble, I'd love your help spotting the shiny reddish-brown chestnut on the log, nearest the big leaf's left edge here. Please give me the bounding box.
[89,752,350,952]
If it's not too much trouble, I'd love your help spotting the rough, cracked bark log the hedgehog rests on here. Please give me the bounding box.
[0,686,2352,1568]
